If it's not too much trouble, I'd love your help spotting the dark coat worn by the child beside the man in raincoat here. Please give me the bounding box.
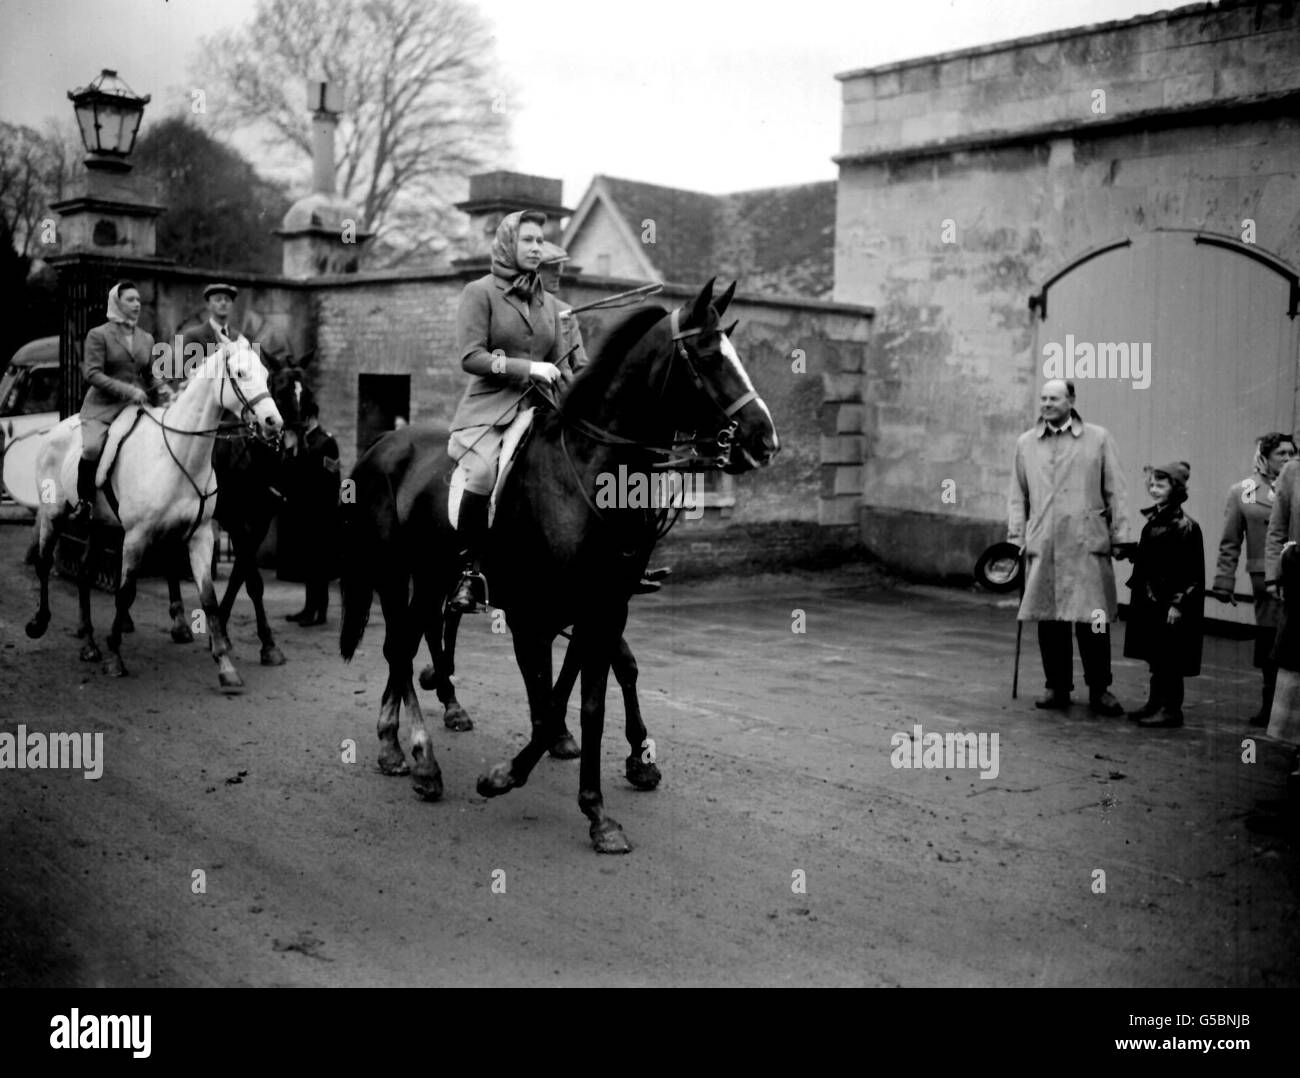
[1125,506,1205,677]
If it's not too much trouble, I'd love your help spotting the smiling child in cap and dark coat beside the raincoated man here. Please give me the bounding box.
[1125,460,1205,727]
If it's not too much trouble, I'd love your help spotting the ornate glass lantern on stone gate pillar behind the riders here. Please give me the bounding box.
[48,69,170,416]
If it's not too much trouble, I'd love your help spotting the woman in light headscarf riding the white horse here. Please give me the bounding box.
[73,281,159,523]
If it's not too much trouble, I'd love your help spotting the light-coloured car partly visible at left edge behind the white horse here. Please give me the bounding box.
[0,337,60,510]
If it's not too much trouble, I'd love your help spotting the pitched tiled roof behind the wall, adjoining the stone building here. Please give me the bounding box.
[593,176,836,298]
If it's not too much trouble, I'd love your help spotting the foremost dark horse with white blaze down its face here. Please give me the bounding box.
[339,281,779,853]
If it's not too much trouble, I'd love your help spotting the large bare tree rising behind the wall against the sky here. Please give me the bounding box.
[203,0,507,263]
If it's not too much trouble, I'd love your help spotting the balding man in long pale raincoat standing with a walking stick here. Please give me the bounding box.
[1008,380,1128,716]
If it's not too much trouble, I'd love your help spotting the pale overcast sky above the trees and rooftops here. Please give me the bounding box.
[0,0,1177,207]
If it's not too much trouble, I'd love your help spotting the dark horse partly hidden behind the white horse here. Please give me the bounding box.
[168,367,311,666]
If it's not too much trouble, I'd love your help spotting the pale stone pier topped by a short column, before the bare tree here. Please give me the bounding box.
[276,79,373,278]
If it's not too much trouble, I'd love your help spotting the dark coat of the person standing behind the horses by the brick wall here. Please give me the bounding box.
[276,427,341,583]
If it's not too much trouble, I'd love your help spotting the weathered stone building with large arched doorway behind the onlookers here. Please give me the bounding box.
[835,0,1300,618]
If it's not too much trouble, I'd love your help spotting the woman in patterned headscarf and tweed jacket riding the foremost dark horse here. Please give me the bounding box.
[447,211,572,614]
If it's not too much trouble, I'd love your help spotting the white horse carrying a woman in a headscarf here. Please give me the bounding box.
[27,339,283,689]
